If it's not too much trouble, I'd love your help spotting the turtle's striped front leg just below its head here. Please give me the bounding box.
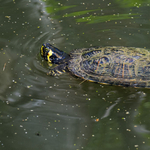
[47,64,67,76]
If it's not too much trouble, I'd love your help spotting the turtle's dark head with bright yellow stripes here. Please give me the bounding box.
[40,43,67,64]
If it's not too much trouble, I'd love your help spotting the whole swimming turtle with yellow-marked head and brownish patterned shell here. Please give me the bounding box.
[40,43,150,88]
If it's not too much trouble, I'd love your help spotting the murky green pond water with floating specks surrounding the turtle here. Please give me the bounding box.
[0,0,150,150]
